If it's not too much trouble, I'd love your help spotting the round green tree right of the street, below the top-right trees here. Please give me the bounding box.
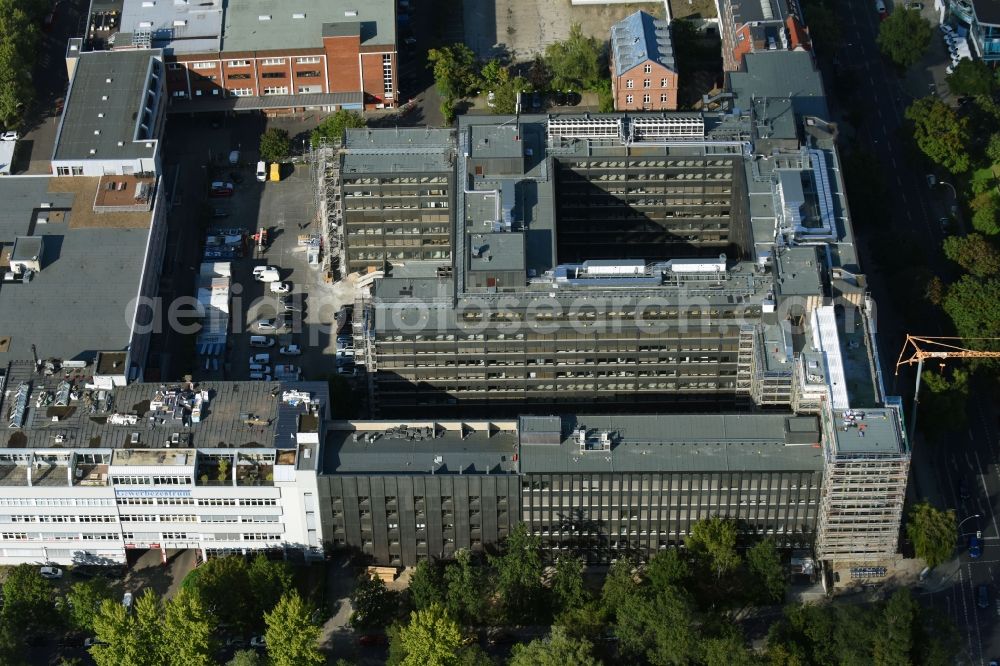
[908,96,970,173]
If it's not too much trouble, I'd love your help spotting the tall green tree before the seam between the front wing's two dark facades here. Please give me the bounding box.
[490,523,543,623]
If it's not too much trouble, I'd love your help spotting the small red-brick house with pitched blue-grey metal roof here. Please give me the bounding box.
[611,11,679,111]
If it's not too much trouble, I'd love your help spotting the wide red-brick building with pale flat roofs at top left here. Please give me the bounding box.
[94,0,398,111]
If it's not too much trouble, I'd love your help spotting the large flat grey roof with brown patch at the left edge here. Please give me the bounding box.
[0,176,152,365]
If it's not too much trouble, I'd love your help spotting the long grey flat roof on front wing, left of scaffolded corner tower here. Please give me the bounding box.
[520,414,823,474]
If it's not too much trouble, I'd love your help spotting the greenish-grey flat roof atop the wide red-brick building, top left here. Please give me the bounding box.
[221,0,396,51]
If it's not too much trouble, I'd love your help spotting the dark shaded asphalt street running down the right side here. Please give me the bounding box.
[826,0,1000,666]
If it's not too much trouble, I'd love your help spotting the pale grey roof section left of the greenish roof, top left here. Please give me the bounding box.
[116,0,223,54]
